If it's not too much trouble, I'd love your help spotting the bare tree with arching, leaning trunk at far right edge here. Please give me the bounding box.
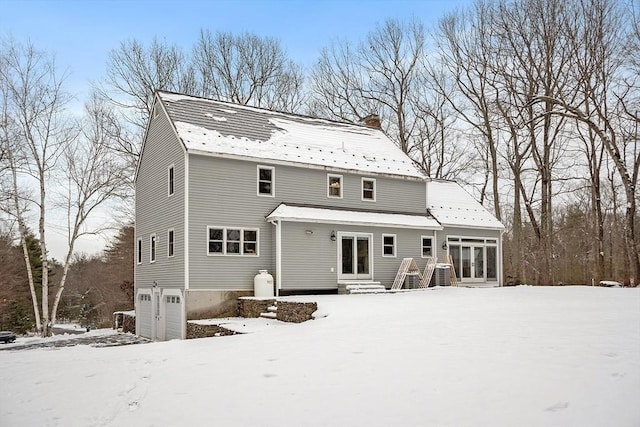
[531,0,640,282]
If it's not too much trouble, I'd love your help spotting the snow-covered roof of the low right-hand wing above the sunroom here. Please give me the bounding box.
[427,181,504,230]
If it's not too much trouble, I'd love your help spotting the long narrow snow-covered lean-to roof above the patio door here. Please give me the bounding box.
[267,203,442,230]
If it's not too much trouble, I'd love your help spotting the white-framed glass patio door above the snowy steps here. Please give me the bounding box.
[338,233,373,280]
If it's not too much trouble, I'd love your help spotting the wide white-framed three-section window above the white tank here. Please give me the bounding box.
[207,227,259,256]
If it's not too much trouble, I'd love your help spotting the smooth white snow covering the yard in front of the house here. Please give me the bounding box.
[0,286,640,427]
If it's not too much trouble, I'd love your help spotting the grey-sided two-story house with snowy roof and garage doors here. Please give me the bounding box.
[135,92,503,339]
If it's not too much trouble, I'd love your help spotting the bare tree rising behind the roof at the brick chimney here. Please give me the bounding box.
[310,20,425,155]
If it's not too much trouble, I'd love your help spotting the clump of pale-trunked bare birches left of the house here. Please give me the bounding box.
[0,40,125,336]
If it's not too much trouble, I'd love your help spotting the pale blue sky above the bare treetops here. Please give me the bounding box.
[0,0,472,259]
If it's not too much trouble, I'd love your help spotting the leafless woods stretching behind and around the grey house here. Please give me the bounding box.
[0,0,640,336]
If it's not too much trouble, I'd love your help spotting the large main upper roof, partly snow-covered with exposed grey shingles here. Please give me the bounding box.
[158,92,425,179]
